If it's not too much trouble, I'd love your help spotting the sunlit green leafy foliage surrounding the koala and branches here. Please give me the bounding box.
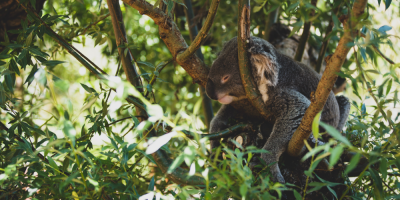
[0,0,400,199]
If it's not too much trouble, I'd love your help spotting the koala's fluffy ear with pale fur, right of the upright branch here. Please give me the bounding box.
[249,39,280,86]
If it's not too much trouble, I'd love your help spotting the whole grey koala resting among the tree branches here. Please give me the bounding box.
[206,37,350,183]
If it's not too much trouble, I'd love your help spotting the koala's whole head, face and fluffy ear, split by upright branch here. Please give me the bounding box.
[206,37,280,104]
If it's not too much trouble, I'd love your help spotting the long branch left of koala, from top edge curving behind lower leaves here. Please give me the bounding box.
[107,0,205,185]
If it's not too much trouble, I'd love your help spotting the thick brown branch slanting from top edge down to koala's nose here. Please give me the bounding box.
[123,0,208,86]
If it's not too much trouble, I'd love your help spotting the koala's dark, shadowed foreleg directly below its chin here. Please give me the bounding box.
[209,104,235,150]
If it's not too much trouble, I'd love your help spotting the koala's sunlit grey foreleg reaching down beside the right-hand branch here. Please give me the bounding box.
[261,90,310,183]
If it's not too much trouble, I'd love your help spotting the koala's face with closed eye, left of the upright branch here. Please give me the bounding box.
[206,40,246,104]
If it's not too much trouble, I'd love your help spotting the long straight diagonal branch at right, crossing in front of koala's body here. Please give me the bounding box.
[288,0,367,156]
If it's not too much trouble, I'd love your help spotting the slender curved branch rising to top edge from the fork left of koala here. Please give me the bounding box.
[176,0,220,61]
